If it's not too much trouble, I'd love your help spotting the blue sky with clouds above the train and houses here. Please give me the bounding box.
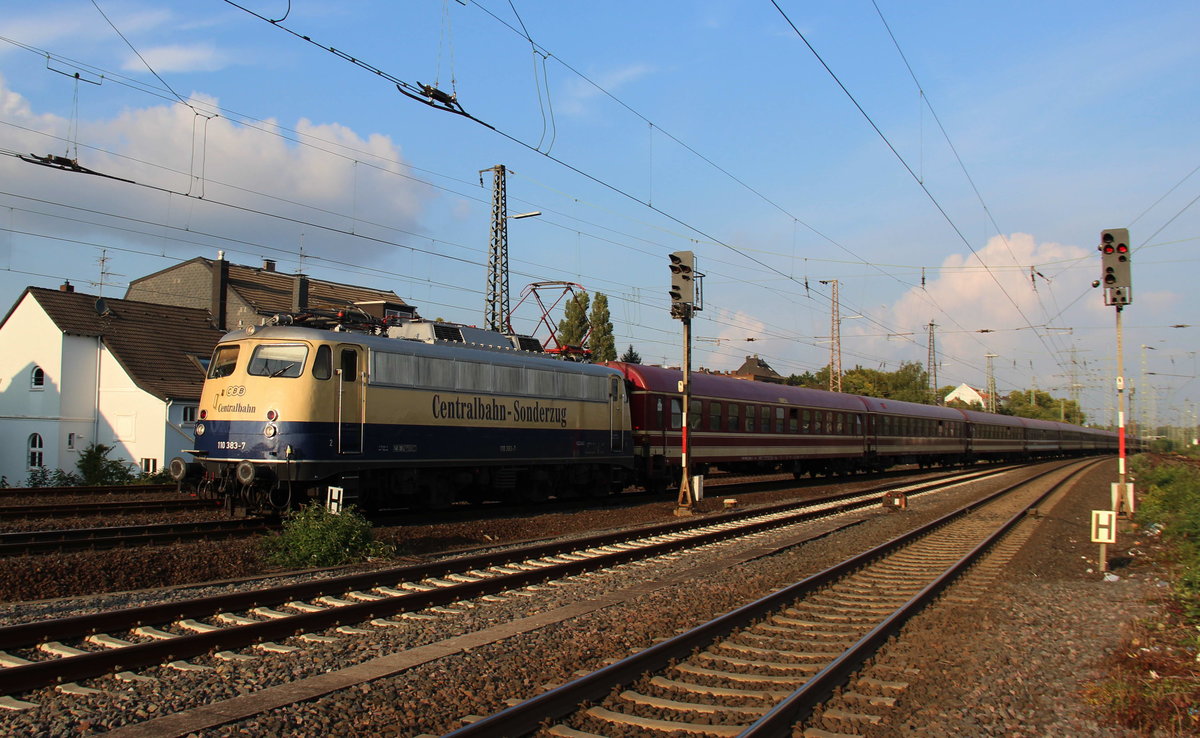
[0,0,1200,425]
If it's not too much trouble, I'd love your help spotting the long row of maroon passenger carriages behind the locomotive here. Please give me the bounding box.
[608,361,1116,490]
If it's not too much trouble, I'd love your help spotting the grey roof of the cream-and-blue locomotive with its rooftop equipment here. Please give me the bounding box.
[221,325,616,376]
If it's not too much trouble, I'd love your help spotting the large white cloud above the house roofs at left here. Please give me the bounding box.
[0,78,431,278]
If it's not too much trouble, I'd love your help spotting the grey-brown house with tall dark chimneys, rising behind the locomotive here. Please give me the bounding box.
[125,252,415,330]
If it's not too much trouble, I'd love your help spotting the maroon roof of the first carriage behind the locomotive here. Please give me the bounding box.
[607,361,863,413]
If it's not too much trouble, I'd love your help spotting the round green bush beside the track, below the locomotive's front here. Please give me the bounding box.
[263,503,395,569]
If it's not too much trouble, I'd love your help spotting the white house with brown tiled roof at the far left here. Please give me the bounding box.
[0,283,224,486]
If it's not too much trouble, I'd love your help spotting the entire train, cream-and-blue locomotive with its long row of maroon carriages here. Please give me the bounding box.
[169,311,1117,511]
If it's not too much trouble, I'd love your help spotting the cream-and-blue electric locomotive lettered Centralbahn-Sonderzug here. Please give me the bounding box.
[172,312,632,510]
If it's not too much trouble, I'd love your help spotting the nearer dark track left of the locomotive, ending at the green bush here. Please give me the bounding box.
[0,518,275,557]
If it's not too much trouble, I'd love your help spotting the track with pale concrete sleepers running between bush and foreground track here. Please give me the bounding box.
[0,470,1001,709]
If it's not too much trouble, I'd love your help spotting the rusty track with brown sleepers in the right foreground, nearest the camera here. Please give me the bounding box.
[450,462,1096,738]
